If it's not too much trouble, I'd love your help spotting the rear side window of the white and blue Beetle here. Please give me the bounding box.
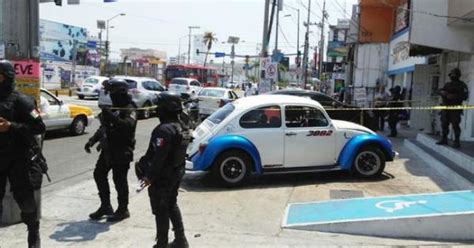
[239,106,281,128]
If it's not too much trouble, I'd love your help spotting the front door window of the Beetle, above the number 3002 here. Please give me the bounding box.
[285,106,329,128]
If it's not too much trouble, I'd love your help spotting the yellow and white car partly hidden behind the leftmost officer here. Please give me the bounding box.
[40,89,94,135]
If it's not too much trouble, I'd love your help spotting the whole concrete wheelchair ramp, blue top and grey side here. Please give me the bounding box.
[283,191,474,241]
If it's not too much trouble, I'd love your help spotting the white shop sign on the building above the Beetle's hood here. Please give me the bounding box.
[388,31,426,74]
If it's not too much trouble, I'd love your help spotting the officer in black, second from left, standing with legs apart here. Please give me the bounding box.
[85,79,137,222]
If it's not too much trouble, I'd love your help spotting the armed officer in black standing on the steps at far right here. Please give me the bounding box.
[436,68,469,148]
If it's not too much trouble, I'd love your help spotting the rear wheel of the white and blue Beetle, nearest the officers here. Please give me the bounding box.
[212,150,252,187]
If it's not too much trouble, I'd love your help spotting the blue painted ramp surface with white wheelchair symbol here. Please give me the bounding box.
[284,191,474,226]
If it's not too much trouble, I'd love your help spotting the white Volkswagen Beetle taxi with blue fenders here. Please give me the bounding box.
[186,95,396,186]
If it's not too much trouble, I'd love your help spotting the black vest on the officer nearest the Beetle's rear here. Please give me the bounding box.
[168,122,192,168]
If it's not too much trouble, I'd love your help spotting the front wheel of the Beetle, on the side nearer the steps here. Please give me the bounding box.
[352,146,385,178]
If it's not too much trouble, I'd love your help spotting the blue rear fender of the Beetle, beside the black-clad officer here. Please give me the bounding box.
[191,135,262,174]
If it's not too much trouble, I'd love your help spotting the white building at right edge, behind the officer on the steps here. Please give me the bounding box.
[409,0,474,141]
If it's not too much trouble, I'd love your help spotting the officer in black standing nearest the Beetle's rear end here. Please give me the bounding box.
[136,92,191,248]
